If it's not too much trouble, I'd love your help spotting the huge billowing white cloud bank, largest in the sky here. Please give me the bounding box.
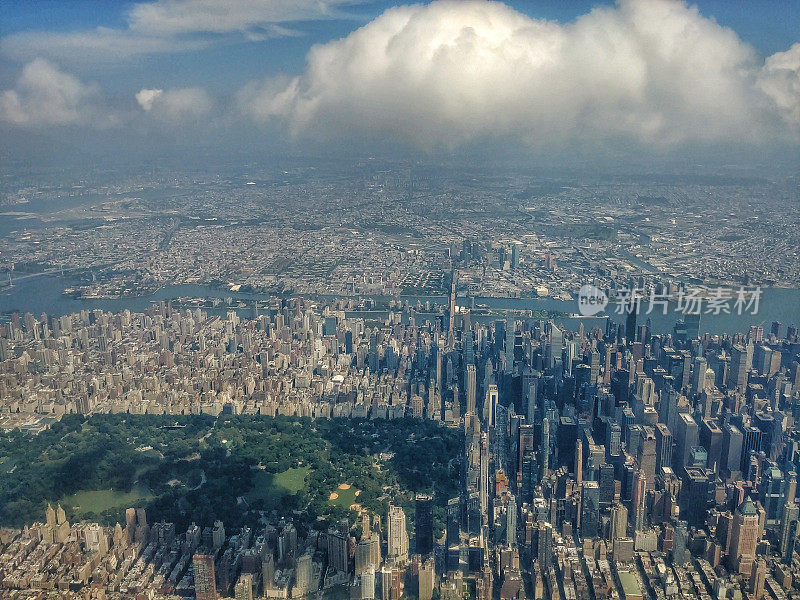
[238,0,800,148]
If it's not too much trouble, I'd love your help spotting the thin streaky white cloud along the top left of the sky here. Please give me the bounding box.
[0,0,358,62]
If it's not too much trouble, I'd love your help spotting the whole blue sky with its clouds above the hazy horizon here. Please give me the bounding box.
[0,0,800,171]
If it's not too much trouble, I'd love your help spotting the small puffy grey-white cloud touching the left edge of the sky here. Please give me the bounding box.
[0,58,115,127]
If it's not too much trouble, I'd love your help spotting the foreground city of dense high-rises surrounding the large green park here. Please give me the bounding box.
[0,211,800,600]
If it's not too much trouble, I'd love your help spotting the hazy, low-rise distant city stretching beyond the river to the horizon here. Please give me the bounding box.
[0,161,800,300]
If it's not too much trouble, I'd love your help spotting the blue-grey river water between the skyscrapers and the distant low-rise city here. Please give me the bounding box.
[0,276,800,334]
